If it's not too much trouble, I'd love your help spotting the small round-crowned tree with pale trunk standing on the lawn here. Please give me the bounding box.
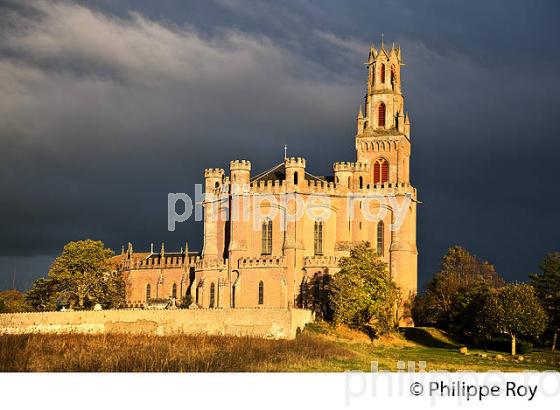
[477,283,547,355]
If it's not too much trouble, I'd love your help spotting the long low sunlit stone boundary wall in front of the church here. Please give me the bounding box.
[0,308,313,339]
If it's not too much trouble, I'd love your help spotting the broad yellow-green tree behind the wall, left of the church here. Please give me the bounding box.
[27,239,125,310]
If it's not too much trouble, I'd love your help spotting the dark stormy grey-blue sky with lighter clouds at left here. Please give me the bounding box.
[0,0,560,289]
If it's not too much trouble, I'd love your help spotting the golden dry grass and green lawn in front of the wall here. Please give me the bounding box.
[0,323,560,372]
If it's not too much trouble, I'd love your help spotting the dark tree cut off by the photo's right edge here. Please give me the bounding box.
[529,252,560,351]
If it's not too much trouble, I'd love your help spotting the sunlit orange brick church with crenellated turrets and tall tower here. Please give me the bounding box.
[117,44,417,308]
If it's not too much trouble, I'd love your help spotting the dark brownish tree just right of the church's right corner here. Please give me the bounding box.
[412,246,503,329]
